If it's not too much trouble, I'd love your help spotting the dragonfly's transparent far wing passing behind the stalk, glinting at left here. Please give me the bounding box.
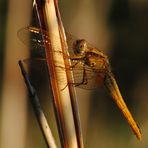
[17,26,76,57]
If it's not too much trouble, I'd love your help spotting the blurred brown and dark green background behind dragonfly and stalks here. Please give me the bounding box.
[0,0,148,148]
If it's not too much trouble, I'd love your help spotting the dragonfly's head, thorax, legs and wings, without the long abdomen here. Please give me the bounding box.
[18,26,110,89]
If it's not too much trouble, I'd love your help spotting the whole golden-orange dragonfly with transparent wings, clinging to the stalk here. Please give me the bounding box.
[18,26,142,140]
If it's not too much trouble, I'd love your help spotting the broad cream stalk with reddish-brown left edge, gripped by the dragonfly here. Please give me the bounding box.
[33,0,78,148]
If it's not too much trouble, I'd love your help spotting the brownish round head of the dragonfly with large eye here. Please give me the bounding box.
[74,39,88,55]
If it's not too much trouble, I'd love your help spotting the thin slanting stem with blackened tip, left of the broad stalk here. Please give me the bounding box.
[18,61,57,148]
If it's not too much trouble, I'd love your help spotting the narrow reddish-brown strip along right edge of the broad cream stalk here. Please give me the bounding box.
[55,0,84,148]
